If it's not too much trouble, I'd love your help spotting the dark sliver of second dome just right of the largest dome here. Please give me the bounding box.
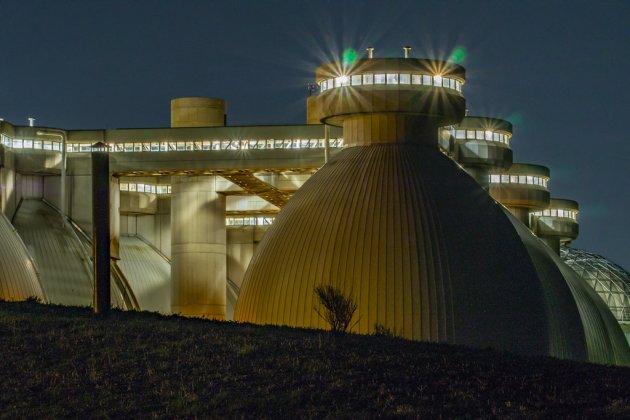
[504,209,589,361]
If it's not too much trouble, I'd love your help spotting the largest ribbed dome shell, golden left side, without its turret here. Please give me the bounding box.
[235,144,550,354]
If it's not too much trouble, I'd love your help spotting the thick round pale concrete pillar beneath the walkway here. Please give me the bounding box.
[171,176,226,319]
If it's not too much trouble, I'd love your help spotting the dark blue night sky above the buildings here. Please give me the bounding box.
[0,0,630,269]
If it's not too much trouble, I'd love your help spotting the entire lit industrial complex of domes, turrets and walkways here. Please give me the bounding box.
[0,50,630,364]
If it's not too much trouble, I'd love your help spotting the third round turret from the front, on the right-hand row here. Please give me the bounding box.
[489,163,549,226]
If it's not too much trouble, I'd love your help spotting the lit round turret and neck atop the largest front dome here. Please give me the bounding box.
[308,58,466,146]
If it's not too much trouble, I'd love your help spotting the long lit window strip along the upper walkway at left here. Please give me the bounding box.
[2,135,343,153]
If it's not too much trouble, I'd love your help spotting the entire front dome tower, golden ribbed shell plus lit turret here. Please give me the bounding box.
[235,51,586,360]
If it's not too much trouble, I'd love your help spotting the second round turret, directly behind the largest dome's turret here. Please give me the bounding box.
[453,116,512,189]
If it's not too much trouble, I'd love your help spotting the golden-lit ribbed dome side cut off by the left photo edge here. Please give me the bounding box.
[0,212,46,301]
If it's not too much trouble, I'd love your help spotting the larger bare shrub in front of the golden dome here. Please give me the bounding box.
[315,285,357,333]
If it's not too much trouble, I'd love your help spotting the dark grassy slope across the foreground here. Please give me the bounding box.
[0,302,630,418]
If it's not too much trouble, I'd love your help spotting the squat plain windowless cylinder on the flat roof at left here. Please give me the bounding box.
[171,97,226,128]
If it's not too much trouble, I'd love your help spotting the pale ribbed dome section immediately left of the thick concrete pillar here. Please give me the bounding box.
[118,236,171,314]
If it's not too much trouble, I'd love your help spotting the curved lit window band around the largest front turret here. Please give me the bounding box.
[319,73,462,93]
